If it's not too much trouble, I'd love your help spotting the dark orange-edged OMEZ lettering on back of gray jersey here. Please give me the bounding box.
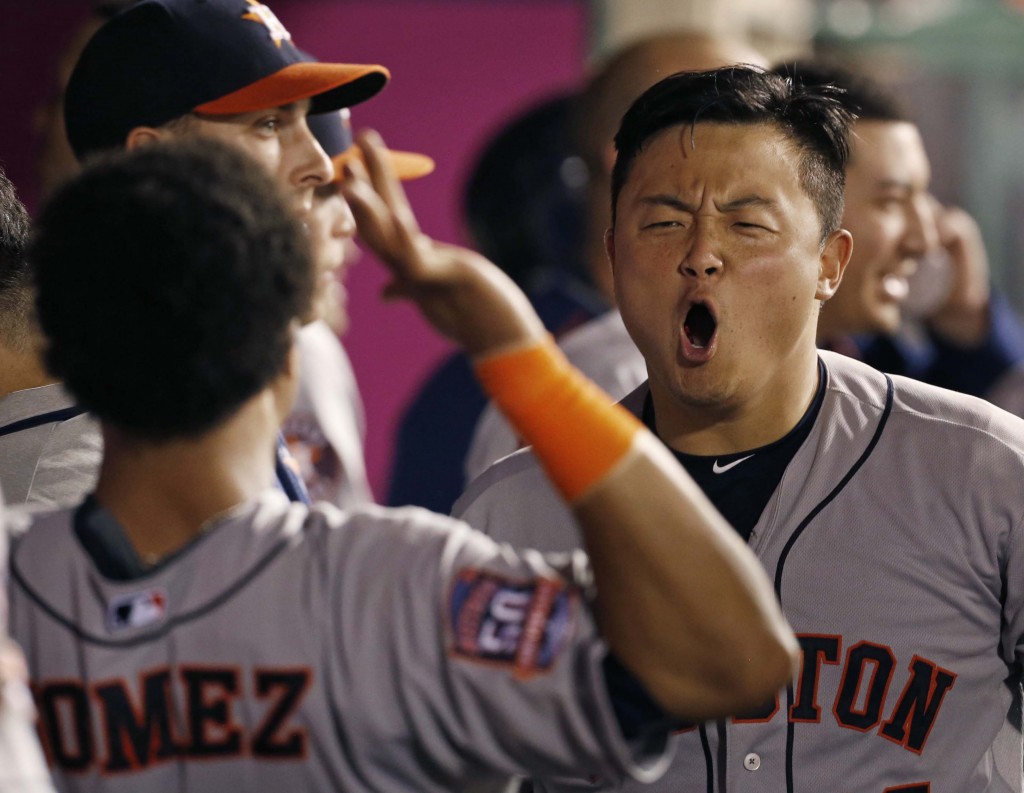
[33,665,313,774]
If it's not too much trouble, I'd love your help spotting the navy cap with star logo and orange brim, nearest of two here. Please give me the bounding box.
[65,0,390,159]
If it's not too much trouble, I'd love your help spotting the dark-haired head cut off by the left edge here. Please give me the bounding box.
[0,168,32,351]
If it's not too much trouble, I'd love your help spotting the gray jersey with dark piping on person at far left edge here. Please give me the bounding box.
[0,383,102,507]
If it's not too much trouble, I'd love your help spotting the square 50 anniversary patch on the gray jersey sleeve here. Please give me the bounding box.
[449,569,578,677]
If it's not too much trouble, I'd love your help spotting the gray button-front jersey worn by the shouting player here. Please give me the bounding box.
[455,352,1024,793]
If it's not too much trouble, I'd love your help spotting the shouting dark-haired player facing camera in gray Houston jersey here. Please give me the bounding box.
[455,68,1024,793]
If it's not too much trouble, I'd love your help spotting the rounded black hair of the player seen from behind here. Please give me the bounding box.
[30,138,314,442]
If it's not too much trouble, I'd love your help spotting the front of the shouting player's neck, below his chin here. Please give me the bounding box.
[650,347,818,455]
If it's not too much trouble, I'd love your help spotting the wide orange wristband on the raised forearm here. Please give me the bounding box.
[474,339,642,503]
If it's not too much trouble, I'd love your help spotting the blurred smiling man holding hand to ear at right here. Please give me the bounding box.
[776,59,1024,397]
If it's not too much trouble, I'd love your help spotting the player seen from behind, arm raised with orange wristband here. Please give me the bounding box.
[4,133,796,791]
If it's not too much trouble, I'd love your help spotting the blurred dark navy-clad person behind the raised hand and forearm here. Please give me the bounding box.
[388,95,607,512]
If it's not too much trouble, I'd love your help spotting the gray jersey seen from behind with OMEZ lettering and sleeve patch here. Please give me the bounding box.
[10,492,667,793]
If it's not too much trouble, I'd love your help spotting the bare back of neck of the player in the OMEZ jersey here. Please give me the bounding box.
[96,391,279,557]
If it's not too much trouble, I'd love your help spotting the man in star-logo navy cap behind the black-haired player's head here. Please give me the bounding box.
[57,0,399,500]
